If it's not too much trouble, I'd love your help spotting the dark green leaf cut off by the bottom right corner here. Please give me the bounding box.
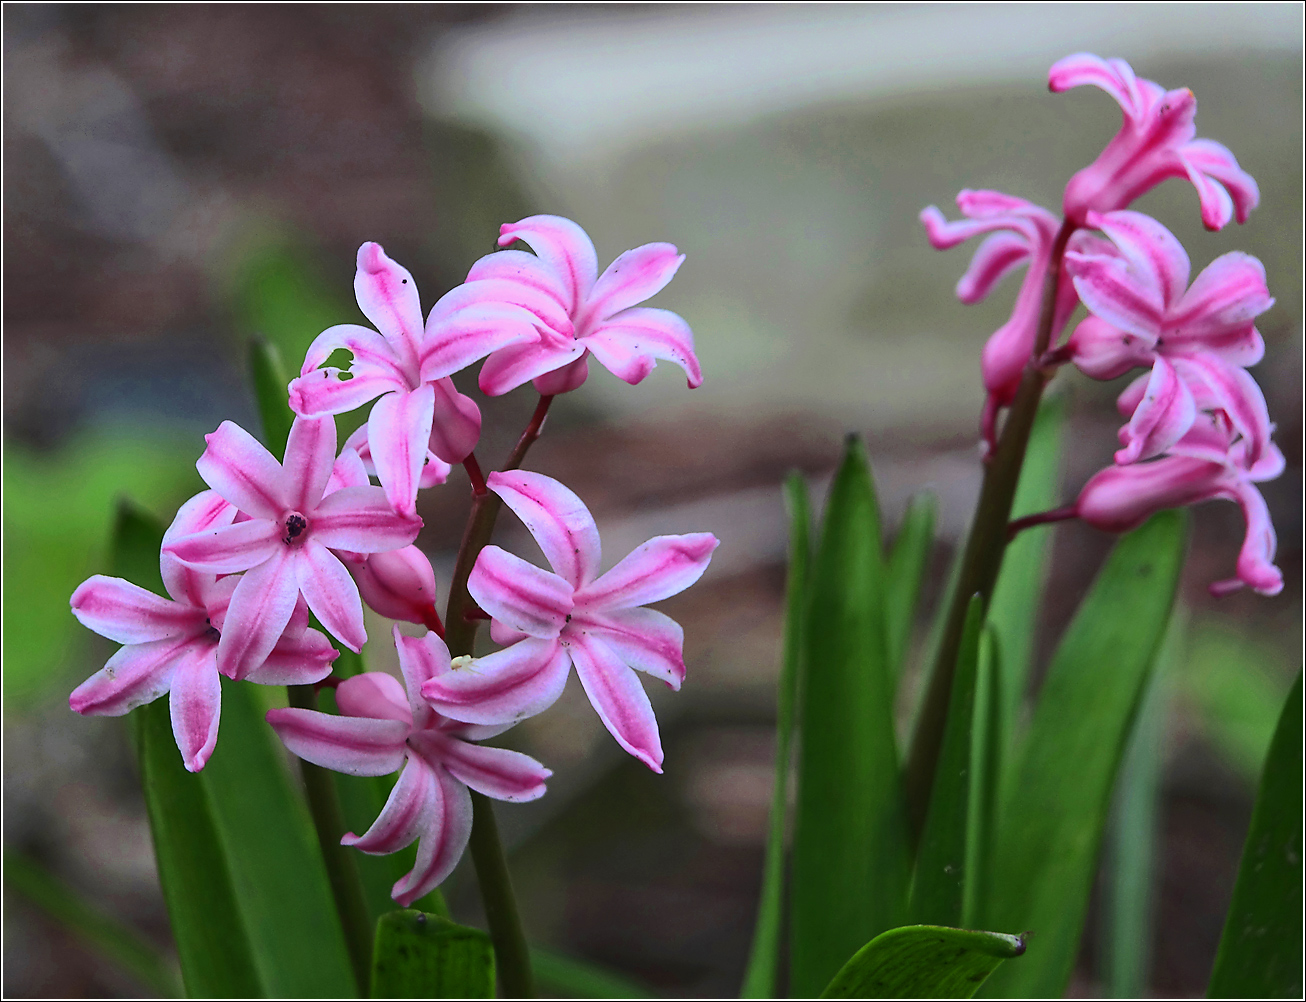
[1207,674,1302,998]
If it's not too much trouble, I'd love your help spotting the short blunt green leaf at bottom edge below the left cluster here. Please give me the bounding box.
[371,909,494,998]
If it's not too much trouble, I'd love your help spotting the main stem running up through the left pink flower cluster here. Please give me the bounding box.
[444,396,554,998]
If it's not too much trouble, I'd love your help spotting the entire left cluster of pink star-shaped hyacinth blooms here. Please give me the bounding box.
[71,216,717,905]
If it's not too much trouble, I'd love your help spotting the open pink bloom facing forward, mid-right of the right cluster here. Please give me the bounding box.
[1057,212,1275,464]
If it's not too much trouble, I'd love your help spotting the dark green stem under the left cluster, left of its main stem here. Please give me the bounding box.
[286,686,372,997]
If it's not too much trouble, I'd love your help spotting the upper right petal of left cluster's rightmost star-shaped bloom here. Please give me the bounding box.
[576,532,720,611]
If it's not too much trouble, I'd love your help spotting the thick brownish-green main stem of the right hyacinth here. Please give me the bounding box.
[902,219,1075,836]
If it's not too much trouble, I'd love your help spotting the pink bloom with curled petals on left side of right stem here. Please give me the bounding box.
[921,189,1076,449]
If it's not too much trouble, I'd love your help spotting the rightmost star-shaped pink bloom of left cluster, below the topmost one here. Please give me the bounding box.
[422,470,718,772]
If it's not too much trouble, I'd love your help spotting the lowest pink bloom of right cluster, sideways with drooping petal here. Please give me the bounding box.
[1075,413,1284,596]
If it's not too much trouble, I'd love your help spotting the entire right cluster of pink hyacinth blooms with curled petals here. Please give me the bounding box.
[921,54,1284,594]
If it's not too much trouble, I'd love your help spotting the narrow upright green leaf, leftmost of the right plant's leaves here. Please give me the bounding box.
[741,473,811,998]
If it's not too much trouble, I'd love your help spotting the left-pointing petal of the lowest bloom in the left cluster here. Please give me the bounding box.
[268,707,409,776]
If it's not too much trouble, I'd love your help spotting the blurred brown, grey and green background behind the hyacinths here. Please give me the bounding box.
[3,4,1302,997]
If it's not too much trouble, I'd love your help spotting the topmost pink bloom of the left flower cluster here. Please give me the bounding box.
[468,216,703,396]
